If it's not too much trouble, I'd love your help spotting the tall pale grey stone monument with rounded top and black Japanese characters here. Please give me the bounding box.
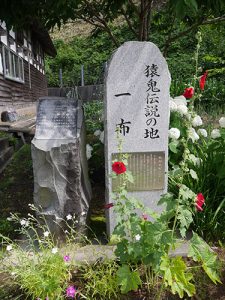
[105,41,171,235]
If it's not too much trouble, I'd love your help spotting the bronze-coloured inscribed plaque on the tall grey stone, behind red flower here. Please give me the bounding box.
[112,151,165,192]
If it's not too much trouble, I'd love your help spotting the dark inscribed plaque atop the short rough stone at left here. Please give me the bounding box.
[35,99,77,139]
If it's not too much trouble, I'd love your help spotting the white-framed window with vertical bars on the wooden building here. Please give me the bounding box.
[2,46,24,82]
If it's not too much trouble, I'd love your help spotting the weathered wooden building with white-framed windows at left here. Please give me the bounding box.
[0,21,56,112]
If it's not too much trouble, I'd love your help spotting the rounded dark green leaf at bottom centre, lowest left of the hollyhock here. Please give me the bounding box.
[117,265,141,294]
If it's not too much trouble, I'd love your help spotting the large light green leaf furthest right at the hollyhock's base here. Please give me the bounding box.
[188,233,221,284]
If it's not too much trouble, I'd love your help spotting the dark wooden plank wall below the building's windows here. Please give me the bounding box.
[0,61,48,109]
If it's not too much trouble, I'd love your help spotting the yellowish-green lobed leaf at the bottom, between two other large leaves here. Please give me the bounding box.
[160,256,195,298]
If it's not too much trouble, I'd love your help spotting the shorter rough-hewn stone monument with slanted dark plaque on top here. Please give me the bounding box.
[32,97,91,236]
